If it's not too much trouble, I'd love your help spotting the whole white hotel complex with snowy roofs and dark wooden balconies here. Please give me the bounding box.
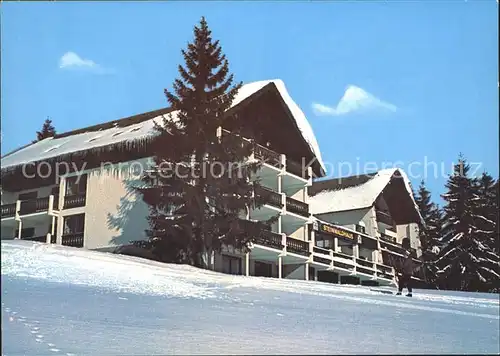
[1,80,419,284]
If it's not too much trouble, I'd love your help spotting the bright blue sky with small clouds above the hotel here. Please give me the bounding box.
[1,0,499,200]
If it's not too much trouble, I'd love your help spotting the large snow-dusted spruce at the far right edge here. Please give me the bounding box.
[437,155,499,291]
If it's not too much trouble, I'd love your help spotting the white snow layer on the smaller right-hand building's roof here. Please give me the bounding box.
[309,168,422,219]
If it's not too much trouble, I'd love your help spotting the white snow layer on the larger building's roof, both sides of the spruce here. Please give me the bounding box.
[1,79,326,171]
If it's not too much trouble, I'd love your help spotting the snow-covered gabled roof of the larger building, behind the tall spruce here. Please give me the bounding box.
[1,79,325,174]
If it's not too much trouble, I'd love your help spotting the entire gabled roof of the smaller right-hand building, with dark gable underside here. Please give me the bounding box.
[309,168,422,222]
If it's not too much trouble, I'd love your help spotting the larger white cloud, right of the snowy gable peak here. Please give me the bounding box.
[312,85,397,116]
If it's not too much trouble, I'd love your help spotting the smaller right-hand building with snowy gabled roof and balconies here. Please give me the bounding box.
[309,169,425,283]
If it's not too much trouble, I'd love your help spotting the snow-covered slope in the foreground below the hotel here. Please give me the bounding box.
[1,241,500,355]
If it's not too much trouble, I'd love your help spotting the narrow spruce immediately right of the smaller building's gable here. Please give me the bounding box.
[415,180,443,286]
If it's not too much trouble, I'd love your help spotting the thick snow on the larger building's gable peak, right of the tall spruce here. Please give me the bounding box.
[233,79,326,176]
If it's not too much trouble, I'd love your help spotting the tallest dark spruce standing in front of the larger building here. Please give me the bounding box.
[139,18,275,268]
